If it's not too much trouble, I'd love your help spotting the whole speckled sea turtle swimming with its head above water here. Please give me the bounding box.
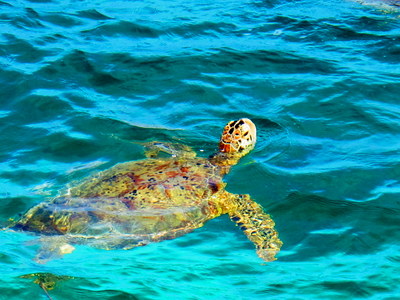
[11,118,282,262]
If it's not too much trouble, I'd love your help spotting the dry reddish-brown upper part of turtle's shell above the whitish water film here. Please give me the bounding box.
[69,158,225,210]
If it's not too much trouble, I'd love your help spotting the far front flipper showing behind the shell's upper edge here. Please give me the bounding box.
[144,142,196,158]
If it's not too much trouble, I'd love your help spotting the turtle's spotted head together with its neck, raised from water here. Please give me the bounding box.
[211,118,257,166]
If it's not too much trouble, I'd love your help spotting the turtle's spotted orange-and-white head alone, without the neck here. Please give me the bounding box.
[219,118,257,157]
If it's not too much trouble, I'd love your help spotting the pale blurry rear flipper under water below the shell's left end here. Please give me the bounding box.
[31,236,75,264]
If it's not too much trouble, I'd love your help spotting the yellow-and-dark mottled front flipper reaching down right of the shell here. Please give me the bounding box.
[229,195,283,261]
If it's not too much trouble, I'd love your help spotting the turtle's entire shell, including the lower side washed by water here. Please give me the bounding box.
[14,158,225,249]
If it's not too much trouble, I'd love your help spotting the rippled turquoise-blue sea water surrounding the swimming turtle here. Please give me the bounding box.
[0,0,400,299]
